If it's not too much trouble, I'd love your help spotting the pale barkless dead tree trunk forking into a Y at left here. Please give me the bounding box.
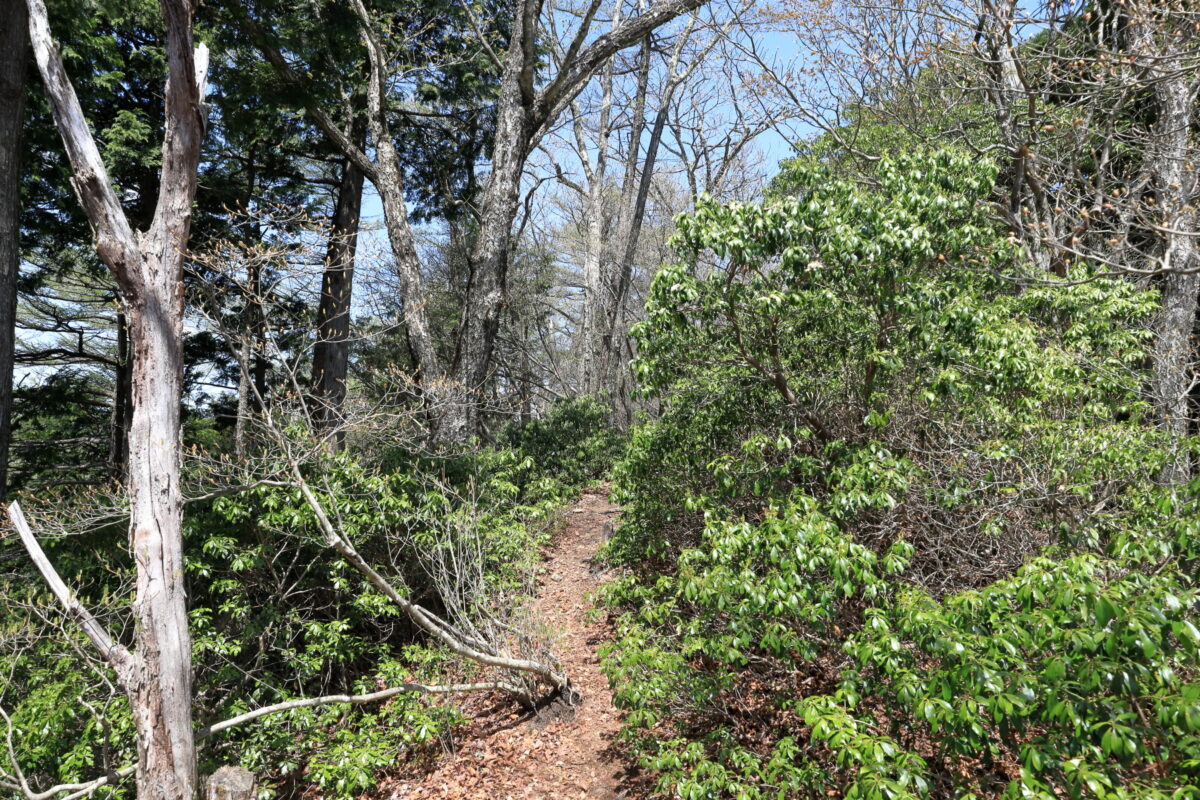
[28,0,208,800]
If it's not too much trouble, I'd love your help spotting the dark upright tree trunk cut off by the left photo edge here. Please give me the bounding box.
[0,0,29,499]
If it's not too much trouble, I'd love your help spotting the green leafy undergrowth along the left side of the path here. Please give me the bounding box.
[0,399,619,799]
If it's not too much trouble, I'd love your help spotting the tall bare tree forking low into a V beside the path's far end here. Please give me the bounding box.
[245,0,704,443]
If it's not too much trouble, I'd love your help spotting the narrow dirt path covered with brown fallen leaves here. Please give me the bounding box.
[377,486,644,800]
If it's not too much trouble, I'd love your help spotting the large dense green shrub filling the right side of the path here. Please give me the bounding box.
[605,152,1200,800]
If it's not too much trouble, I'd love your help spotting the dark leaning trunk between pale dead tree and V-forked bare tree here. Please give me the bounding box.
[312,149,364,450]
